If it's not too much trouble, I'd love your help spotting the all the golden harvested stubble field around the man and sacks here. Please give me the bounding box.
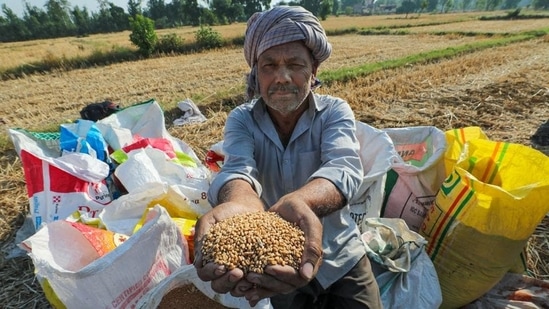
[0,10,549,308]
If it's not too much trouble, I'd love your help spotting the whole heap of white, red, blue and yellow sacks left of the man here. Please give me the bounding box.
[9,100,247,308]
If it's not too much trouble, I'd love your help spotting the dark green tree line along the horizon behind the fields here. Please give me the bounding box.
[0,0,549,42]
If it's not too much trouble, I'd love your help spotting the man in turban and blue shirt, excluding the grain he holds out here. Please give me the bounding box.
[195,7,381,309]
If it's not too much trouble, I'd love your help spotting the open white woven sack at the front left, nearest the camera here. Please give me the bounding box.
[21,206,188,309]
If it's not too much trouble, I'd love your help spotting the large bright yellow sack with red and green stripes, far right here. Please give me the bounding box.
[420,139,549,308]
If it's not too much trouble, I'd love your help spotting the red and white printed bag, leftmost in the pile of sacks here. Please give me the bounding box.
[9,129,113,229]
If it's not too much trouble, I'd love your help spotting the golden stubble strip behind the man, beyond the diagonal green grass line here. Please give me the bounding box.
[0,34,510,128]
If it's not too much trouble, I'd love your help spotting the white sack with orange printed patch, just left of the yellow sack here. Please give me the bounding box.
[381,126,446,232]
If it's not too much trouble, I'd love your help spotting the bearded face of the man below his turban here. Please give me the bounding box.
[257,41,316,115]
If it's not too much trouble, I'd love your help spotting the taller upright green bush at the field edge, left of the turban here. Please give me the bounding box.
[130,15,158,57]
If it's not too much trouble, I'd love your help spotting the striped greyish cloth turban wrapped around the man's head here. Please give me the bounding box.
[244,6,332,99]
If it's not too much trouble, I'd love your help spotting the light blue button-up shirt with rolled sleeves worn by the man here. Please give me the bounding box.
[208,94,366,288]
